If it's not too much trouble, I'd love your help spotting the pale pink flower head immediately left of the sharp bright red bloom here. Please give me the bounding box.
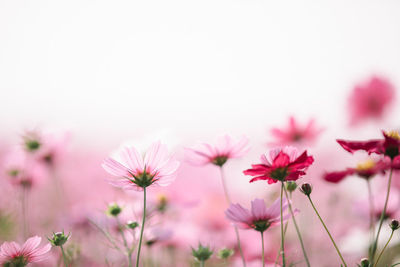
[186,135,250,166]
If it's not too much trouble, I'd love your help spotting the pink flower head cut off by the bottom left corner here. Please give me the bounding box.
[0,236,51,266]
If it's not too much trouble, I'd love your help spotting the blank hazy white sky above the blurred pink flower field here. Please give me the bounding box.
[0,0,400,146]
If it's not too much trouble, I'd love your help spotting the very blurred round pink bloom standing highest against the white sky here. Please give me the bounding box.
[348,76,395,124]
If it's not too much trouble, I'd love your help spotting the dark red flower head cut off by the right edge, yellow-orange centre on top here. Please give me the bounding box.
[336,131,400,160]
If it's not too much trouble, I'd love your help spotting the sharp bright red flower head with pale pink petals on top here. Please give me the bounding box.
[243,146,314,184]
